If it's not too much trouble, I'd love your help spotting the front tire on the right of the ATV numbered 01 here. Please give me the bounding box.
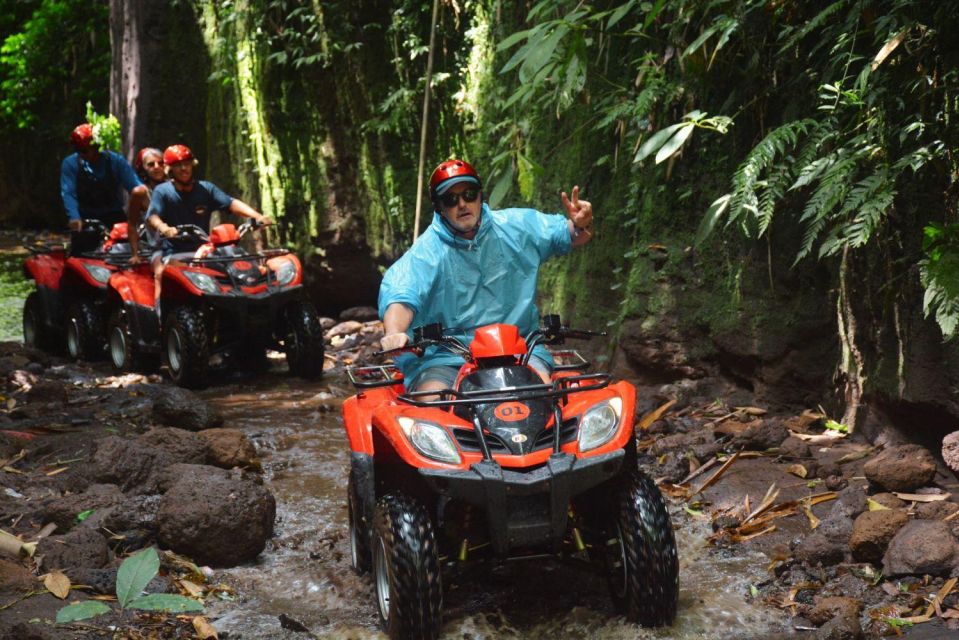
[602,470,679,627]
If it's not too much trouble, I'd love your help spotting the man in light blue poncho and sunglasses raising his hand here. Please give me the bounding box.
[379,159,593,391]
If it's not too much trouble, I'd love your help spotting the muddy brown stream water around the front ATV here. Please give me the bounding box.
[204,372,788,640]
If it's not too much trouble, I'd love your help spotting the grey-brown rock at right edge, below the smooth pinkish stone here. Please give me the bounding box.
[882,520,959,576]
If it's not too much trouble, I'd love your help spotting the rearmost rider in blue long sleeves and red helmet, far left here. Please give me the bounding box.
[60,123,148,254]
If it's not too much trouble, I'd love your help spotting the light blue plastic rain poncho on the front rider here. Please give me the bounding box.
[379,203,572,383]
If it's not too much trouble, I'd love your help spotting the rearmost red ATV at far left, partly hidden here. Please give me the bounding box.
[23,220,144,360]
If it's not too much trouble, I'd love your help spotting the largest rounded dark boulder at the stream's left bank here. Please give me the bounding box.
[157,465,276,567]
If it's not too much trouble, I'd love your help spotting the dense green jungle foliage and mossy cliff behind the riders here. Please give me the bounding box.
[0,0,959,427]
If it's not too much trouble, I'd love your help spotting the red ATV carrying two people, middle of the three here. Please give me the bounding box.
[108,221,324,387]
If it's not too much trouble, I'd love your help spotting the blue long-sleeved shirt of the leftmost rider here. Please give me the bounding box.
[60,151,143,220]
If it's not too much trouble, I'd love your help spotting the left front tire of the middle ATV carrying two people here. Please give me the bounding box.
[163,307,210,389]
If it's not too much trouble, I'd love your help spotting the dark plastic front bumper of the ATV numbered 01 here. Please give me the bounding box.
[419,450,625,556]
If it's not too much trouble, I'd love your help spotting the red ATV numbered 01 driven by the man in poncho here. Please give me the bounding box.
[343,316,679,638]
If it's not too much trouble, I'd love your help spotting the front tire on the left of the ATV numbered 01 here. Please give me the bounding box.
[372,493,443,640]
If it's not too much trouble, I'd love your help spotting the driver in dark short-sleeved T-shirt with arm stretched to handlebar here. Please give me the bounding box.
[147,144,273,317]
